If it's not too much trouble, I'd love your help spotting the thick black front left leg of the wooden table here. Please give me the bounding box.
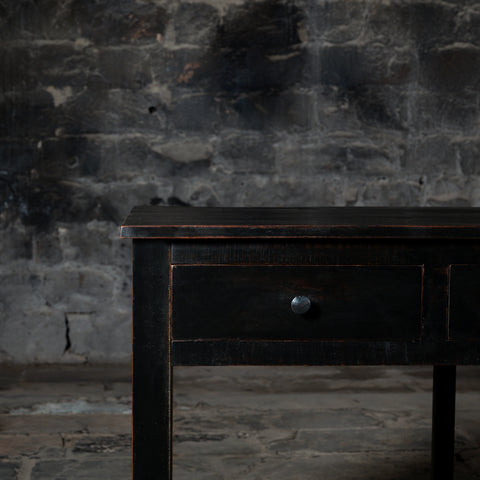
[133,239,172,480]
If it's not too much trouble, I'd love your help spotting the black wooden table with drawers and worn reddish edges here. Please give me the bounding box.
[121,206,480,480]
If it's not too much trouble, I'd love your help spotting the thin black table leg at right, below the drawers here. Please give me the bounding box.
[432,365,456,480]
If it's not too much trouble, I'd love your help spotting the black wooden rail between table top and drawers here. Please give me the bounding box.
[172,238,480,268]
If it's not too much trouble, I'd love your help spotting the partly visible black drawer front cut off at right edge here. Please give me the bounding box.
[448,265,480,341]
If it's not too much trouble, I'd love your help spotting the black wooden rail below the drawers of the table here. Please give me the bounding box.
[172,340,480,365]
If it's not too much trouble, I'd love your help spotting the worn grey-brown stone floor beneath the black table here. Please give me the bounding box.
[0,367,480,480]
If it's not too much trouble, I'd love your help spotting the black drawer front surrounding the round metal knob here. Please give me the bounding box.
[172,265,423,340]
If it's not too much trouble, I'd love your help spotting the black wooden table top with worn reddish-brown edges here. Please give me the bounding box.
[121,205,480,239]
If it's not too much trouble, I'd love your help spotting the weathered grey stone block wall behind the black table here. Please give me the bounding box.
[0,0,480,362]
